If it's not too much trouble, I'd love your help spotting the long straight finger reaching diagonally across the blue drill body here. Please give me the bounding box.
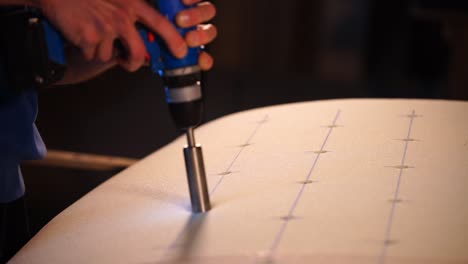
[135,1,188,58]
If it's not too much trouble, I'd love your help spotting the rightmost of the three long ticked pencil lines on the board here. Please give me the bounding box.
[377,110,421,264]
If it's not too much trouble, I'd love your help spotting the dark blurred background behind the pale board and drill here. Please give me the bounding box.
[23,0,468,233]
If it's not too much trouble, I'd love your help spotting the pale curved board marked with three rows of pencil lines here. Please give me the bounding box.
[12,100,468,264]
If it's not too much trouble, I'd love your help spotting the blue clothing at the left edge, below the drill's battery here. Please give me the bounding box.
[0,63,46,203]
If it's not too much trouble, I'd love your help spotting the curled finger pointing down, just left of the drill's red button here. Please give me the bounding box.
[119,22,146,72]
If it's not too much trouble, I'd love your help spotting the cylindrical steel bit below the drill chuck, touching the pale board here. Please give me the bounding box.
[184,127,211,213]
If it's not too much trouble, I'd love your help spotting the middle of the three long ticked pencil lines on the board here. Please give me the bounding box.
[262,110,341,263]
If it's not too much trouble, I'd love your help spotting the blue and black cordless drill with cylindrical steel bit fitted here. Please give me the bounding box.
[28,0,211,213]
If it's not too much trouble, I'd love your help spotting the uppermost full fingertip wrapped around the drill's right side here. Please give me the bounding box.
[176,2,216,28]
